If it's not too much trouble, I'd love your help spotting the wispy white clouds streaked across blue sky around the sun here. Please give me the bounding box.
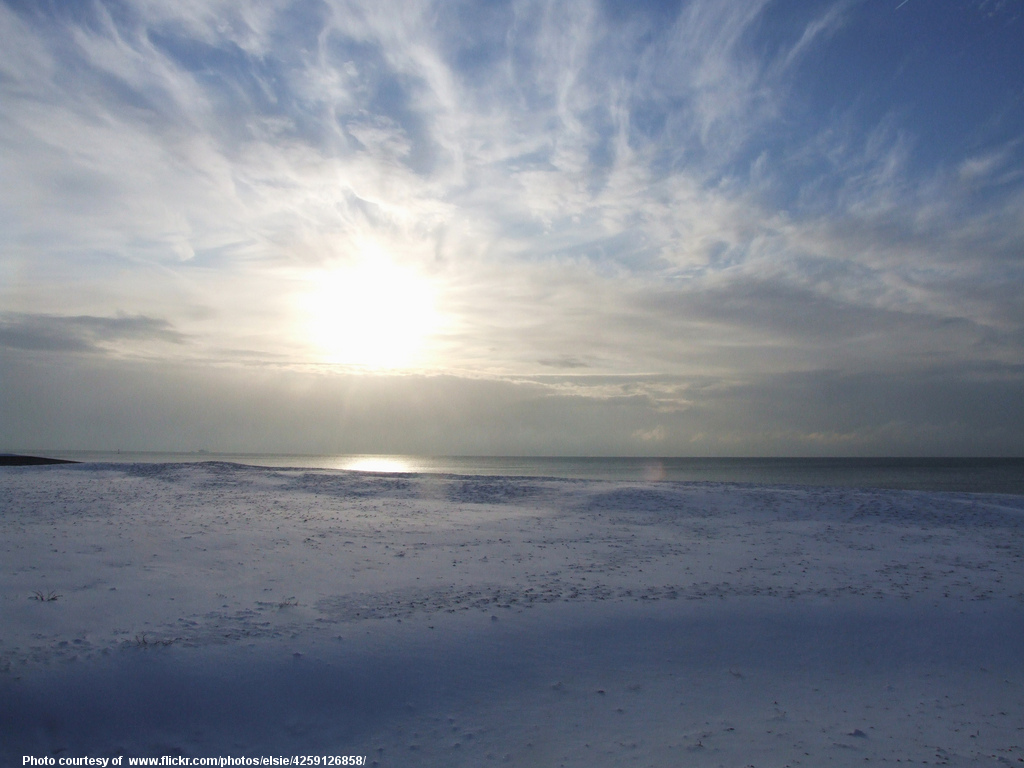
[0,0,1024,454]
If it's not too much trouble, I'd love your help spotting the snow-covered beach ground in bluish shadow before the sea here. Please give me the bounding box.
[0,463,1024,767]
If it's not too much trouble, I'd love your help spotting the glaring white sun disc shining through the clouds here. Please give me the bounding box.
[303,254,437,369]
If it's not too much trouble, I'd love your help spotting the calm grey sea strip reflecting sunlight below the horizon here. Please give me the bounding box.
[32,452,1024,495]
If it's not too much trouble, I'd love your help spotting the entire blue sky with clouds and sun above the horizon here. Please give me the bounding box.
[0,0,1024,456]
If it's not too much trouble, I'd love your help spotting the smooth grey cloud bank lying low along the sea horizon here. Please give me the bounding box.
[0,350,1024,456]
